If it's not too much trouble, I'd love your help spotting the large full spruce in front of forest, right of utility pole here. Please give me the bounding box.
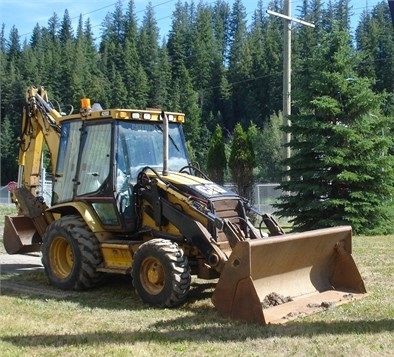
[277,26,393,233]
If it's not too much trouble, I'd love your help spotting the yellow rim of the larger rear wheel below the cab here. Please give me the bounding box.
[49,237,74,279]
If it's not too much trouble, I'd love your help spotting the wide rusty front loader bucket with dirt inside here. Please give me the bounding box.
[212,226,366,324]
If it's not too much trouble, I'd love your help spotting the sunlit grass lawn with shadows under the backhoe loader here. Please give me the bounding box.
[0,204,394,357]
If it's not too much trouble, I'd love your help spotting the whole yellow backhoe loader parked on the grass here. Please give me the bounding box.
[4,86,366,324]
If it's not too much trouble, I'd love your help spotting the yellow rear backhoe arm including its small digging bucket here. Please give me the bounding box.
[3,86,61,254]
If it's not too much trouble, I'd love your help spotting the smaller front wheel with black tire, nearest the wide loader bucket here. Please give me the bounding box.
[131,239,191,307]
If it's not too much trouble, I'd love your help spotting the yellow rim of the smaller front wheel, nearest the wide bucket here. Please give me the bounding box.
[140,257,165,295]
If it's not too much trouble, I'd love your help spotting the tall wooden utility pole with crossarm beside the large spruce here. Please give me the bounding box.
[267,0,315,180]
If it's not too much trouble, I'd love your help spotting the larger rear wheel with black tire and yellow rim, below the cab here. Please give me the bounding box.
[42,216,104,290]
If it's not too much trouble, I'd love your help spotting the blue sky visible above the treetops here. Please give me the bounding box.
[0,0,388,43]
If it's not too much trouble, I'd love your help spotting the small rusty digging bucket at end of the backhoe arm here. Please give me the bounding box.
[3,216,42,254]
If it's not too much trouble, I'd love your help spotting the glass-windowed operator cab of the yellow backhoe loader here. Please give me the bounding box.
[52,109,189,231]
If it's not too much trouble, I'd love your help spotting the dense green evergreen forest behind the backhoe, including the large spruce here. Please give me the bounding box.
[0,0,394,233]
